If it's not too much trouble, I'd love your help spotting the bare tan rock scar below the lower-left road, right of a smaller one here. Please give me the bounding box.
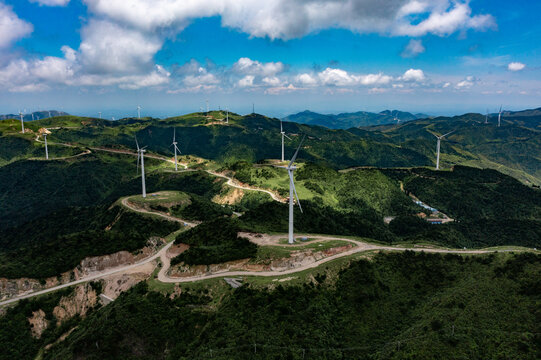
[53,284,98,325]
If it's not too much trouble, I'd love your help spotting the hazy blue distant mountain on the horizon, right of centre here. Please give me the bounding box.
[283,110,429,129]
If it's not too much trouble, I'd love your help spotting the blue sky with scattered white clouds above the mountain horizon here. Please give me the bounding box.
[0,0,541,118]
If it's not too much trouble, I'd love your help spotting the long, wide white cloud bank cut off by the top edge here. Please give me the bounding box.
[84,0,495,40]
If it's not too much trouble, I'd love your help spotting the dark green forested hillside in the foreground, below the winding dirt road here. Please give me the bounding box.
[0,252,541,360]
